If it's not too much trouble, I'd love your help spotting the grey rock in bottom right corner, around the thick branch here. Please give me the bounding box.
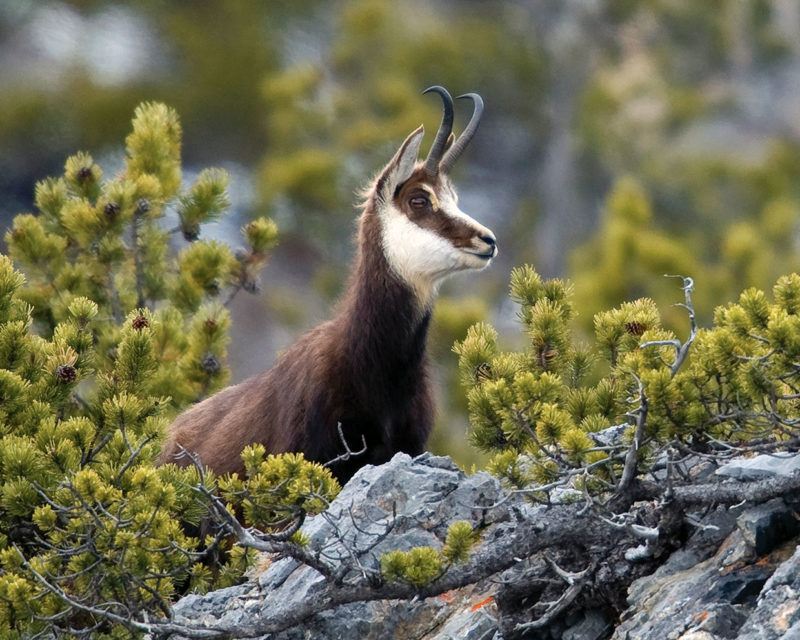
[613,455,800,640]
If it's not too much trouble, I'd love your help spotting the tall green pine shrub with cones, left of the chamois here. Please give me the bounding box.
[0,104,338,639]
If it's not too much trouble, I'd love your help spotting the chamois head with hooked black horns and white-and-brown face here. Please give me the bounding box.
[372,86,497,304]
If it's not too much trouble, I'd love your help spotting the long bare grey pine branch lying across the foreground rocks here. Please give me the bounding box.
[17,462,800,640]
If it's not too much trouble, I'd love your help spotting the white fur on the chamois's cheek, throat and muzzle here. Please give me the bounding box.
[380,189,493,303]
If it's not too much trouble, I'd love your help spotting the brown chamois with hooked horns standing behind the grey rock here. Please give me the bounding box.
[158,86,497,482]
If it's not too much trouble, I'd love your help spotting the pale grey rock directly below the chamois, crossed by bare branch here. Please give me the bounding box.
[174,453,506,640]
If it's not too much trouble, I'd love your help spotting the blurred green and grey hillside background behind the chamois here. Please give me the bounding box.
[0,0,800,470]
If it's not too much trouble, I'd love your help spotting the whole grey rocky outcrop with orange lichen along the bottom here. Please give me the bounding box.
[167,454,800,640]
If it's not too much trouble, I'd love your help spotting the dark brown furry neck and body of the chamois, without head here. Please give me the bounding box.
[159,182,433,481]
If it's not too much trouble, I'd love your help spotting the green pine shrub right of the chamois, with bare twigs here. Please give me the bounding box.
[454,266,800,501]
